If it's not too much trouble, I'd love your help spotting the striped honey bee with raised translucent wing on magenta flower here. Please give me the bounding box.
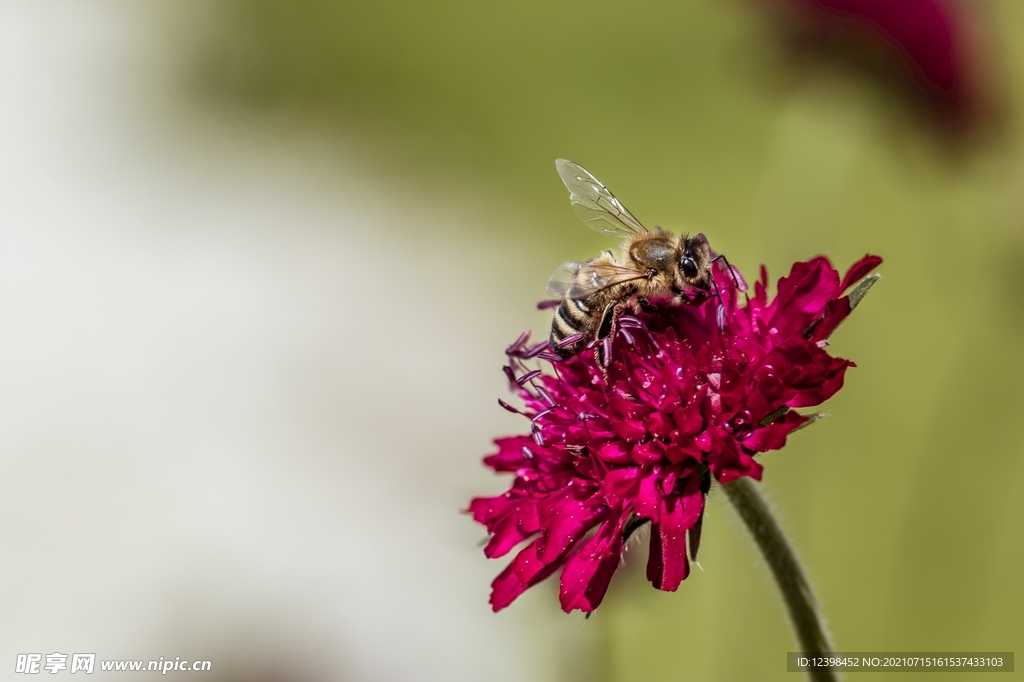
[548,159,738,366]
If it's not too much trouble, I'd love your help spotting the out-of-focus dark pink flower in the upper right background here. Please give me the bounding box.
[759,0,988,131]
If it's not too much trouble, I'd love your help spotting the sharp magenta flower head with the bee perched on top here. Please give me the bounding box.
[469,256,882,612]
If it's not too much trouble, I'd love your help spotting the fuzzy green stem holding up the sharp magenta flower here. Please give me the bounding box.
[722,477,839,682]
